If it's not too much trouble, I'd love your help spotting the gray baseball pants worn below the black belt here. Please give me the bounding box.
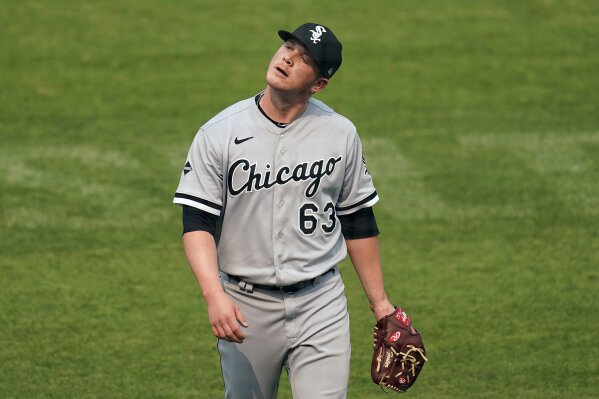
[218,268,351,399]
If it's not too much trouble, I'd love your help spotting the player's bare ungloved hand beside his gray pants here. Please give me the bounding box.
[207,293,248,344]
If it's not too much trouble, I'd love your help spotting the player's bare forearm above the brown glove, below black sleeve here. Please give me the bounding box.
[345,236,395,320]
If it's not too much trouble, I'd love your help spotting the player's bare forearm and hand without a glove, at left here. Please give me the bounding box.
[183,231,248,343]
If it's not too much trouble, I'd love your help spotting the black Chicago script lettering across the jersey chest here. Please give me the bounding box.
[227,156,342,198]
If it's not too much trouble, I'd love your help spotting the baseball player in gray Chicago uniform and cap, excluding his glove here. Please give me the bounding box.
[174,23,394,399]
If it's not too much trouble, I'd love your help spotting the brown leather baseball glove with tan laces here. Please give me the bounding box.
[371,307,428,392]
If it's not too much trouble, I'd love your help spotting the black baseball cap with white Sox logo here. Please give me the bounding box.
[279,22,342,79]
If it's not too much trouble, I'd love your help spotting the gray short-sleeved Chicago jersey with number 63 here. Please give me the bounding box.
[173,94,378,286]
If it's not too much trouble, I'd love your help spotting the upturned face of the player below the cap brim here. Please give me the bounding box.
[266,39,328,94]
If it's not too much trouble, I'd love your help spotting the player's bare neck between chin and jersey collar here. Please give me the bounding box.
[260,86,310,123]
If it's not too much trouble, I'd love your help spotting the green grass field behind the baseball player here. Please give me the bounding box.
[0,0,599,399]
